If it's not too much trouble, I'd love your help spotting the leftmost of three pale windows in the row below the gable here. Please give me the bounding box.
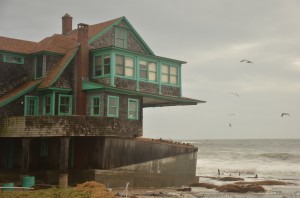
[116,55,134,77]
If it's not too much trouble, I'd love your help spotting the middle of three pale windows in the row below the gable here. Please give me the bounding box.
[139,60,157,81]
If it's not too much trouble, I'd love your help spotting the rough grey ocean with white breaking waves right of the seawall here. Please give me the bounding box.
[190,139,300,183]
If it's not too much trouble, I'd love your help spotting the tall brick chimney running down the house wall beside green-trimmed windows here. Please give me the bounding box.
[76,23,89,115]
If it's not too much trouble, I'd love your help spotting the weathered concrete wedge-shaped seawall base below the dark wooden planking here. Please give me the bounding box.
[95,152,199,187]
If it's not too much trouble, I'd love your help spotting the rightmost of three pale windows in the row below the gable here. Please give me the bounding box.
[161,64,178,85]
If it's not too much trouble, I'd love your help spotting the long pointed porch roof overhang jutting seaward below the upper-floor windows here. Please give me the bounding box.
[82,81,205,107]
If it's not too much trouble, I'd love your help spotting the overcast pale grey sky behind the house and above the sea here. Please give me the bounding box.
[0,0,300,140]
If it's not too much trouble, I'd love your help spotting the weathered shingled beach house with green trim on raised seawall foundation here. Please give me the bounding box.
[0,14,204,186]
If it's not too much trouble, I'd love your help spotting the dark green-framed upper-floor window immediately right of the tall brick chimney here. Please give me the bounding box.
[94,55,110,77]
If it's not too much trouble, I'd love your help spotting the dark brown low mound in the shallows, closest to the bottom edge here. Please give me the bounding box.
[216,184,266,193]
